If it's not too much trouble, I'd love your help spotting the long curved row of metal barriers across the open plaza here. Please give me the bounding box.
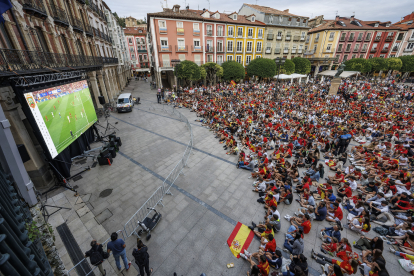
[124,104,193,238]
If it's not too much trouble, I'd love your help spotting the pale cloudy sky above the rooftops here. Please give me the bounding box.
[105,0,414,23]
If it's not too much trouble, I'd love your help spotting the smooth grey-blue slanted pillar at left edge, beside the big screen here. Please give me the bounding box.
[0,105,37,206]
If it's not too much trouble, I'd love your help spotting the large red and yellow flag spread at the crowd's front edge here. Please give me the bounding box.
[227,222,254,258]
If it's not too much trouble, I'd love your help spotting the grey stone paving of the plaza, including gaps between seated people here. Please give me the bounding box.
[50,80,408,276]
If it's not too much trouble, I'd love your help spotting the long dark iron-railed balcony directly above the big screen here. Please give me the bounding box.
[0,49,118,76]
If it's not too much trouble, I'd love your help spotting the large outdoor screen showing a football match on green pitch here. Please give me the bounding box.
[24,80,97,158]
